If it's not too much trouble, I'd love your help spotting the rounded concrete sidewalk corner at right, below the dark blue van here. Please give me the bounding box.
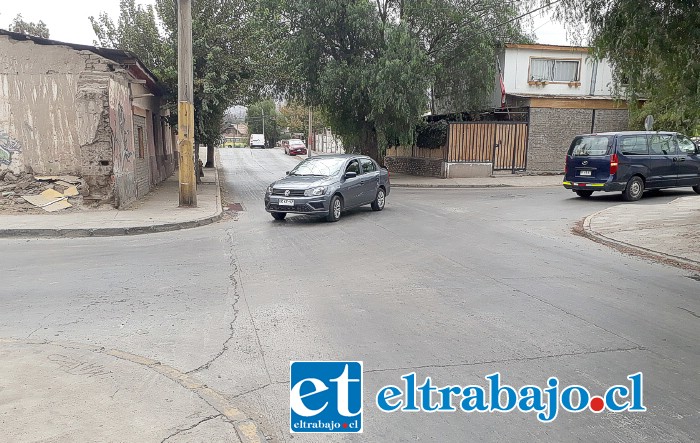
[583,195,700,272]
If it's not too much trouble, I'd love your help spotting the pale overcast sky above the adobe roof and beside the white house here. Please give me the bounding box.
[0,0,568,45]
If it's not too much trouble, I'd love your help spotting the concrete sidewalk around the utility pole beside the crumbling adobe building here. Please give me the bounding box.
[0,168,222,237]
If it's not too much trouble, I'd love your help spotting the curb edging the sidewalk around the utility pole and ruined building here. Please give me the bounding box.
[0,167,223,238]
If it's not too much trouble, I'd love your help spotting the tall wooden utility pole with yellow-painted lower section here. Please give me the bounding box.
[177,0,197,208]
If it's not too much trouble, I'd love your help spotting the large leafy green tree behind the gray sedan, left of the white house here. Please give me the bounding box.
[270,0,523,158]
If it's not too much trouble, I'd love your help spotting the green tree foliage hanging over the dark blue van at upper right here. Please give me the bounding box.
[545,0,700,134]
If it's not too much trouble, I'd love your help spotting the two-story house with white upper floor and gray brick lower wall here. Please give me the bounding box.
[492,44,629,172]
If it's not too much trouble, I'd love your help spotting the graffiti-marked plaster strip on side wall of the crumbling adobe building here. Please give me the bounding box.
[109,80,134,174]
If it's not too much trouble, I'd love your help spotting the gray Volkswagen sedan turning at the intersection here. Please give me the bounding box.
[265,154,390,222]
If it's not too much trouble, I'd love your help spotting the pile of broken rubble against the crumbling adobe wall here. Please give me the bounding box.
[0,170,88,212]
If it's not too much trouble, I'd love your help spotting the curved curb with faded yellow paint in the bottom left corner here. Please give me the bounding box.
[0,337,266,443]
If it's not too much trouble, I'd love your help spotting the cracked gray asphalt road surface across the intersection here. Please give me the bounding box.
[0,149,700,442]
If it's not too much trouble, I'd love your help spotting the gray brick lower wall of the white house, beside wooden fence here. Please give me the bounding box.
[527,108,593,172]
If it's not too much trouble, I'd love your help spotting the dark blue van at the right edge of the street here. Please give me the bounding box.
[563,131,700,201]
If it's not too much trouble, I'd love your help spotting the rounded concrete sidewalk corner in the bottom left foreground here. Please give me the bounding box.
[0,338,265,443]
